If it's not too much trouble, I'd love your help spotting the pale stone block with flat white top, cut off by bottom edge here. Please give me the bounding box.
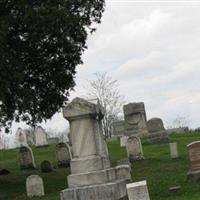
[126,181,150,200]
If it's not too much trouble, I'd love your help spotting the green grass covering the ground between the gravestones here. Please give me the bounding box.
[0,134,200,200]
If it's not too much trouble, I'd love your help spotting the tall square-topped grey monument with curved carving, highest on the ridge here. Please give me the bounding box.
[123,102,148,137]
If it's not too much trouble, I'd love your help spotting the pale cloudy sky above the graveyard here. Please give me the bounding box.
[8,0,200,144]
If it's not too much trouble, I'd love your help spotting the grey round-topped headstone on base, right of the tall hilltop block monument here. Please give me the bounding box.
[147,118,169,144]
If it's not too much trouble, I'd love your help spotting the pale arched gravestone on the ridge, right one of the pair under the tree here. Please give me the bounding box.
[34,126,48,147]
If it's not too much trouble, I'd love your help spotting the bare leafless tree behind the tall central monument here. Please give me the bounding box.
[86,73,123,137]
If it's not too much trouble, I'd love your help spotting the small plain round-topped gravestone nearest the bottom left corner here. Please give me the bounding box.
[26,175,44,197]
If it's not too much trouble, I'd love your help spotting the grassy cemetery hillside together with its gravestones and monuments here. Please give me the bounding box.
[0,98,200,200]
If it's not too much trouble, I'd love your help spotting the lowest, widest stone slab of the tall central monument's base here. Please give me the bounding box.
[60,180,128,200]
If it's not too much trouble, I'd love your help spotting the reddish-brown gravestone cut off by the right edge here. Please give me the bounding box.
[187,141,200,180]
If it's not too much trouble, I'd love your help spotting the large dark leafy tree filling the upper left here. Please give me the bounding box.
[0,0,105,132]
